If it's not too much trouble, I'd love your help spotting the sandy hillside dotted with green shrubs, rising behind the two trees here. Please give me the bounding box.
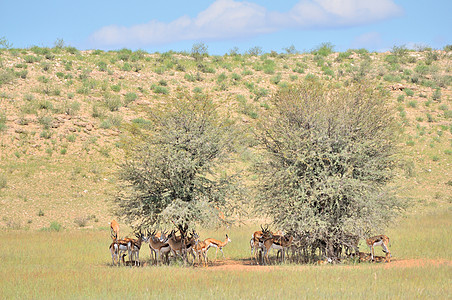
[0,46,452,229]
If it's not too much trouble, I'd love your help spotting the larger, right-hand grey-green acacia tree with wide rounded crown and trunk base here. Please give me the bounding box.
[256,81,403,258]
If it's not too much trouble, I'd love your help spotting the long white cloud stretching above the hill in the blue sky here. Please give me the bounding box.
[90,0,402,46]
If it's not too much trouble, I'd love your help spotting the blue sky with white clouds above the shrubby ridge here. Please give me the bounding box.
[0,0,452,55]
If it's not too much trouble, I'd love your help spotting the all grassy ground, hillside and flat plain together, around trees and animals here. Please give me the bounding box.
[0,47,452,299]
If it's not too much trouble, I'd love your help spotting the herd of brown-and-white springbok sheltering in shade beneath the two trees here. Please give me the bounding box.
[110,220,391,267]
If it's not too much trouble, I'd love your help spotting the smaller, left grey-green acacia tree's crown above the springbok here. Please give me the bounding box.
[115,97,240,228]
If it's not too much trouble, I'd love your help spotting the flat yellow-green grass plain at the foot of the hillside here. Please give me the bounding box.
[0,212,452,299]
